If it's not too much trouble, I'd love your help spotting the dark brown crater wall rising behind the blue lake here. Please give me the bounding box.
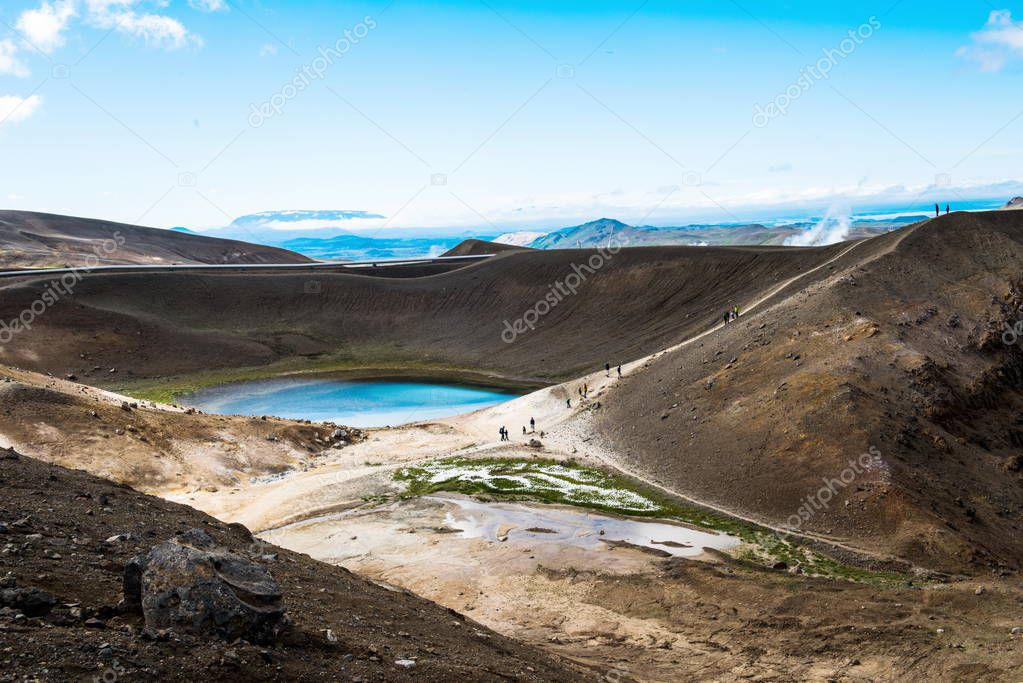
[0,245,847,385]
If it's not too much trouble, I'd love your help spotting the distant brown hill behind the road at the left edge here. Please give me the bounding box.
[0,211,311,269]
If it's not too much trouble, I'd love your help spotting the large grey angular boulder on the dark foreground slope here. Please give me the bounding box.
[124,529,287,643]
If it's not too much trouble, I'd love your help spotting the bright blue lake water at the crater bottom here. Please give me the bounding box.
[181,377,516,427]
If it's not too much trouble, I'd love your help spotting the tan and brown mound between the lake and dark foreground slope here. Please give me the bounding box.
[0,366,361,492]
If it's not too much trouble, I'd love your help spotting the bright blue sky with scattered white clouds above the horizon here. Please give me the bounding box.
[0,0,1023,232]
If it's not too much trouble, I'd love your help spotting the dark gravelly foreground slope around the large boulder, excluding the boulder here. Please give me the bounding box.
[0,451,585,681]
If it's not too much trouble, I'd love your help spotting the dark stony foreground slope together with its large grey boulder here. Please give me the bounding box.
[0,451,585,681]
